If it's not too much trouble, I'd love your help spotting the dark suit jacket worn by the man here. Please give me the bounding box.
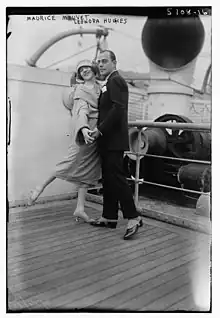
[98,71,129,151]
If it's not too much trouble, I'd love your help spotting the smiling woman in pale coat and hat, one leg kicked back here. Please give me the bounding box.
[28,60,101,222]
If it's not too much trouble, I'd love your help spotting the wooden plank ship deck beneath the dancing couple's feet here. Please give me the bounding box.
[7,199,210,312]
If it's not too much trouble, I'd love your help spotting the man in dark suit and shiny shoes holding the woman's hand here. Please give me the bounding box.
[91,50,143,239]
